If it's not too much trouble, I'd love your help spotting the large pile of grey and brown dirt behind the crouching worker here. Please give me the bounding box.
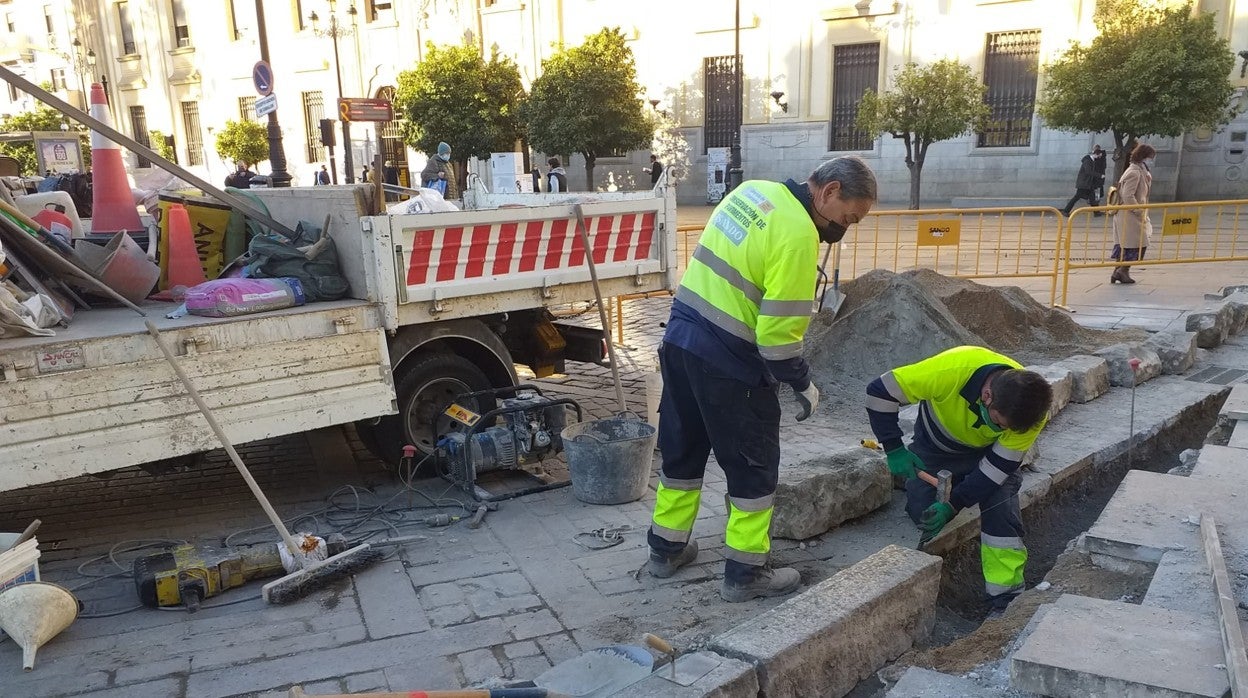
[806,268,1147,390]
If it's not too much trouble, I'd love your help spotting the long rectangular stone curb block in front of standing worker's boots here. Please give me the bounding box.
[710,546,941,698]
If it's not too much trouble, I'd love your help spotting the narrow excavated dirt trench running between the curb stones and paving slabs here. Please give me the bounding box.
[849,391,1229,698]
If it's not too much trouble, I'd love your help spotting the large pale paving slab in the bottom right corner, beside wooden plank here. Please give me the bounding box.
[1010,594,1231,698]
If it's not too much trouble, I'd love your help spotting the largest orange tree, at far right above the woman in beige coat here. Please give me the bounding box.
[1040,0,1234,179]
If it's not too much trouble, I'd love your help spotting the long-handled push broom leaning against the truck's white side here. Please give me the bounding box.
[144,320,384,603]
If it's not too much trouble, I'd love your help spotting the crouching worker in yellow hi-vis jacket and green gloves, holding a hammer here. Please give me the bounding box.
[866,347,1053,612]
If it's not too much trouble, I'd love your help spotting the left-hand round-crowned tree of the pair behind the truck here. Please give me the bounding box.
[394,44,524,189]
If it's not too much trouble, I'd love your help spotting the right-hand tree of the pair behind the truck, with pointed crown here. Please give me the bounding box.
[523,29,654,191]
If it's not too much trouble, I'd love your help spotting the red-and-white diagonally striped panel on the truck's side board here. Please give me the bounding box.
[403,211,658,287]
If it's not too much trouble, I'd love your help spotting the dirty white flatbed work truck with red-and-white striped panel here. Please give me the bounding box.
[0,185,676,491]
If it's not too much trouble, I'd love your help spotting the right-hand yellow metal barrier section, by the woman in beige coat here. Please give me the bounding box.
[1056,200,1248,307]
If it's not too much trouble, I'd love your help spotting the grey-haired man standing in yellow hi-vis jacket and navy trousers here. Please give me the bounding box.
[646,157,876,602]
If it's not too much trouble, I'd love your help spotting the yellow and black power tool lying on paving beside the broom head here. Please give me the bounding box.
[134,536,347,613]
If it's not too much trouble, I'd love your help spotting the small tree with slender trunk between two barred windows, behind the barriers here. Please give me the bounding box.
[856,59,988,209]
